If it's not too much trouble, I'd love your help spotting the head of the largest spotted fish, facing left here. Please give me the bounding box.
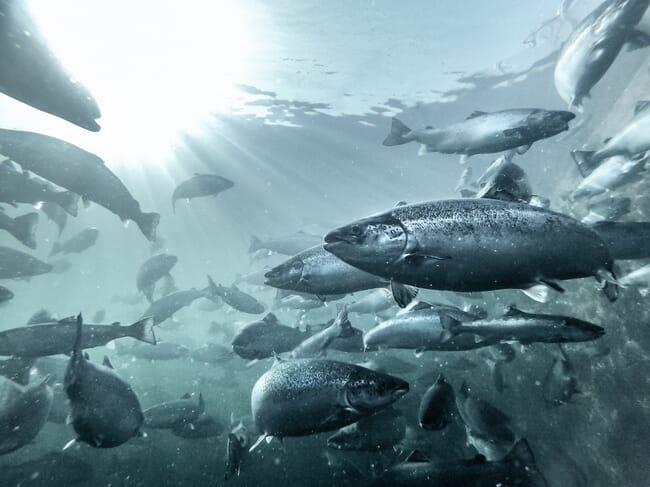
[325,213,407,268]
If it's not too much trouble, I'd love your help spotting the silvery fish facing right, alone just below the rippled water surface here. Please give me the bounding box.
[383,108,575,163]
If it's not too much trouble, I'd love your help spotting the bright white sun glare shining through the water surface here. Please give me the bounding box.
[29,0,255,164]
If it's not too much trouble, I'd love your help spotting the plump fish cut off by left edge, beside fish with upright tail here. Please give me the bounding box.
[0,377,53,455]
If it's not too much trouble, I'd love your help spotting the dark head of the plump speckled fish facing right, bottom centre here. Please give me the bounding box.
[344,368,409,412]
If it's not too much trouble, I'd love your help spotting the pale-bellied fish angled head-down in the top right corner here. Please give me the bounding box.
[554,0,650,109]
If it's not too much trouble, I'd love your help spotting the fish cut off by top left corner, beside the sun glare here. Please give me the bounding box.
[0,0,101,132]
